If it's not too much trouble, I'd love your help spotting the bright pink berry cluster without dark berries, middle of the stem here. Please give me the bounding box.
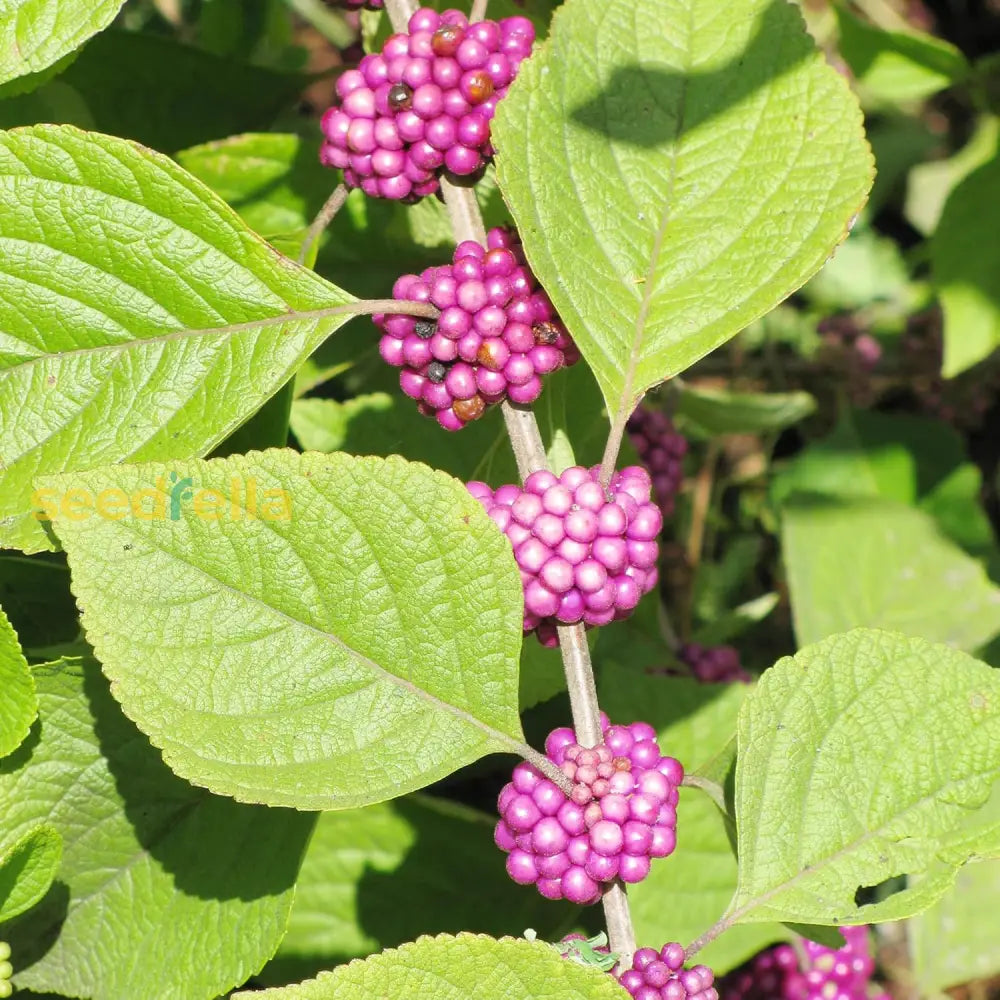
[468,465,663,646]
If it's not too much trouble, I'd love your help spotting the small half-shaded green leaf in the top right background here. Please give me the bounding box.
[834,4,969,104]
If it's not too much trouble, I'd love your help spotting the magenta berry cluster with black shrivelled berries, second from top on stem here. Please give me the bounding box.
[372,228,580,431]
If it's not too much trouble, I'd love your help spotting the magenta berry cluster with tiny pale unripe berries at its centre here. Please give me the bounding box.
[494,715,684,905]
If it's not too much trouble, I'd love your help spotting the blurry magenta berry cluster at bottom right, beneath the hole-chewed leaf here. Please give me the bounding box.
[719,927,889,1000]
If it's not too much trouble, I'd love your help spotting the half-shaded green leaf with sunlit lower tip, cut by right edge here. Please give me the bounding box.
[931,156,1000,378]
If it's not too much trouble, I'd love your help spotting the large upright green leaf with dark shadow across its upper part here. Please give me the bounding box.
[494,0,872,415]
